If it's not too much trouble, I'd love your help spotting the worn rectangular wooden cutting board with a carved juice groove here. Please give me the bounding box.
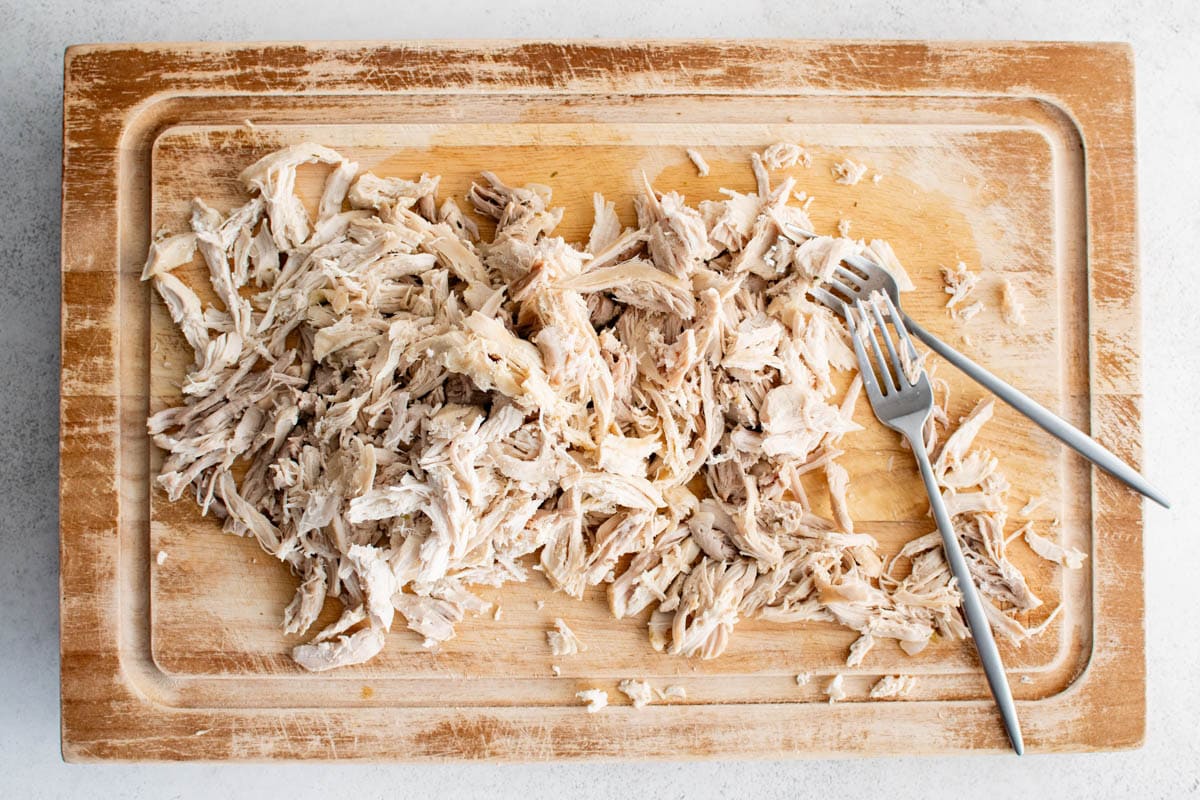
[61,42,1145,760]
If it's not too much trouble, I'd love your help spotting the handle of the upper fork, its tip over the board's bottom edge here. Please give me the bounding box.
[905,428,1025,756]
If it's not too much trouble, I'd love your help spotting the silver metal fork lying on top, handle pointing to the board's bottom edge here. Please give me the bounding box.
[844,294,1025,756]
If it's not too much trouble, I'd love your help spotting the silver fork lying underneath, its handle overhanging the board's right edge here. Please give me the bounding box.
[787,225,1171,509]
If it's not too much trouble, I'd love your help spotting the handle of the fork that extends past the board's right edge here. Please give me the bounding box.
[904,314,1171,509]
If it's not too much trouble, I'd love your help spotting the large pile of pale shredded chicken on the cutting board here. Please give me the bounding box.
[144,144,1052,671]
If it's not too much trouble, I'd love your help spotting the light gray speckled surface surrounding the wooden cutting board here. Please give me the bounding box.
[0,0,1200,800]
